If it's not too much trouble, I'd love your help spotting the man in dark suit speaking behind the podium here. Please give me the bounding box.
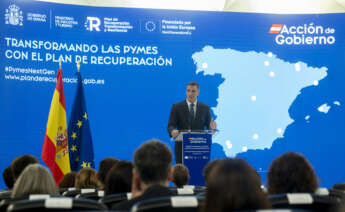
[168,81,217,163]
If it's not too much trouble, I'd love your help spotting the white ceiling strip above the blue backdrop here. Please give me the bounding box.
[38,0,345,14]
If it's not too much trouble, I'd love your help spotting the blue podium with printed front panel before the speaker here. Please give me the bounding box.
[175,130,213,186]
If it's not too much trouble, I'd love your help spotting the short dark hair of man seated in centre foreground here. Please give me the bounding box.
[134,139,172,184]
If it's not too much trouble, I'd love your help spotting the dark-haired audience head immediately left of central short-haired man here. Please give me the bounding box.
[105,161,133,195]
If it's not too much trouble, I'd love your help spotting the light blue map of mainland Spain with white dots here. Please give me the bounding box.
[192,46,327,156]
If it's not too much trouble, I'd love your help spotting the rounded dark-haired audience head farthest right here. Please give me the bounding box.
[267,152,318,194]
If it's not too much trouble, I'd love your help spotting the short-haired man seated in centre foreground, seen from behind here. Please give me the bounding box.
[112,139,173,211]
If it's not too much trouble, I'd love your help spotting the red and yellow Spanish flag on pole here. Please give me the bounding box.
[41,69,71,183]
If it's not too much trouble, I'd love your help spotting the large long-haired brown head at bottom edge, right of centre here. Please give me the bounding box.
[203,158,270,212]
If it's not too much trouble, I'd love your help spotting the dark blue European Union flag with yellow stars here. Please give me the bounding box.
[68,71,95,171]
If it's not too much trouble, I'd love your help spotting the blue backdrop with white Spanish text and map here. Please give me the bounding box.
[0,0,345,188]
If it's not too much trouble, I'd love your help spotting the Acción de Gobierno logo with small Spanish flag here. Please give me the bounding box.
[269,23,335,45]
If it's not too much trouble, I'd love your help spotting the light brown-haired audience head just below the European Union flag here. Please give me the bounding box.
[74,167,100,189]
